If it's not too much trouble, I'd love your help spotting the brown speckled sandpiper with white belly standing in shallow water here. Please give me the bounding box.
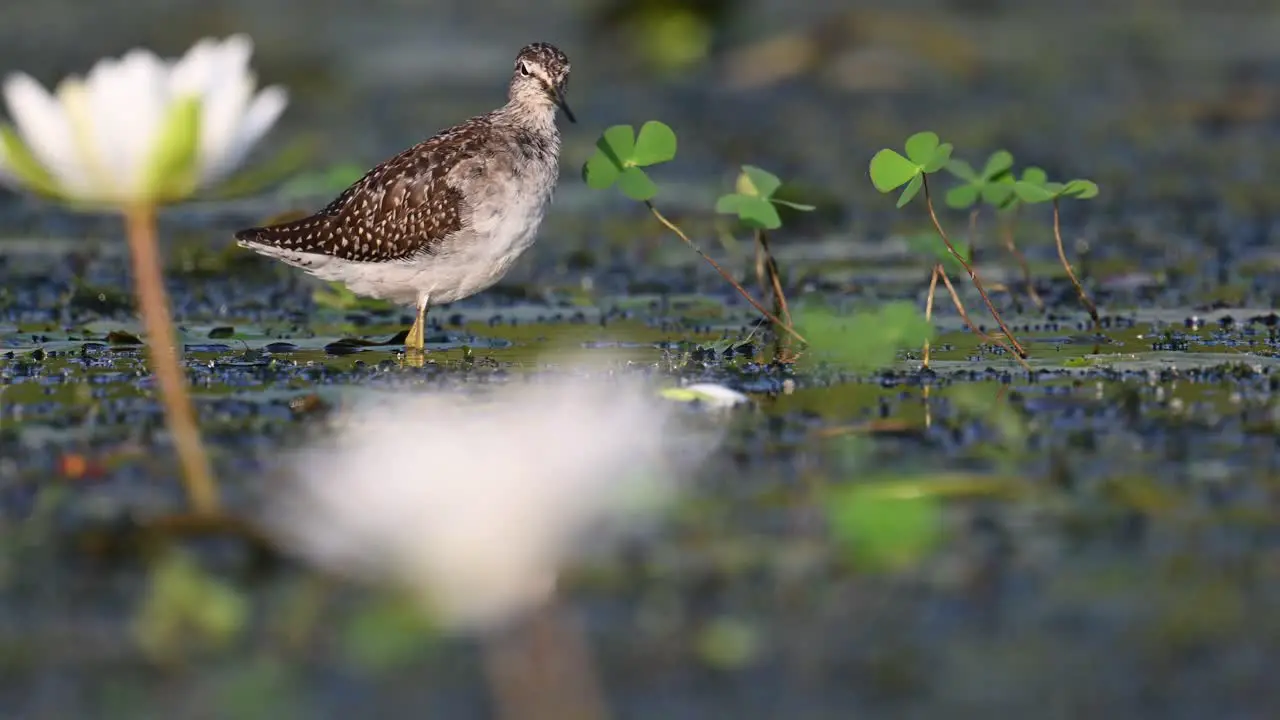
[236,42,576,351]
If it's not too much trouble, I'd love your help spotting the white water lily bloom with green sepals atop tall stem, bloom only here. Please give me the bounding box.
[0,35,288,205]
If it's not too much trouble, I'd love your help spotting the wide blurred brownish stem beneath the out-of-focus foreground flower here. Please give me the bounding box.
[484,600,608,720]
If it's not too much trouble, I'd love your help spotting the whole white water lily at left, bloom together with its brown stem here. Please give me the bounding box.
[0,35,287,514]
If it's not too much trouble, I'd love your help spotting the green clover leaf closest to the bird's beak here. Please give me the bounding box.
[582,120,676,201]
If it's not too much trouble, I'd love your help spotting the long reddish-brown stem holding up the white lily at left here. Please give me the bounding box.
[124,205,220,515]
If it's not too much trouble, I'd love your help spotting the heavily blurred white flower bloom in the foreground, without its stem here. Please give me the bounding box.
[268,371,718,630]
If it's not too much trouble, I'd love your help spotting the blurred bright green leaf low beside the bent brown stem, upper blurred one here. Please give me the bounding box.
[794,301,933,372]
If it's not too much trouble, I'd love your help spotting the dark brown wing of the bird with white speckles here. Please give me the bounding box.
[236,118,490,263]
